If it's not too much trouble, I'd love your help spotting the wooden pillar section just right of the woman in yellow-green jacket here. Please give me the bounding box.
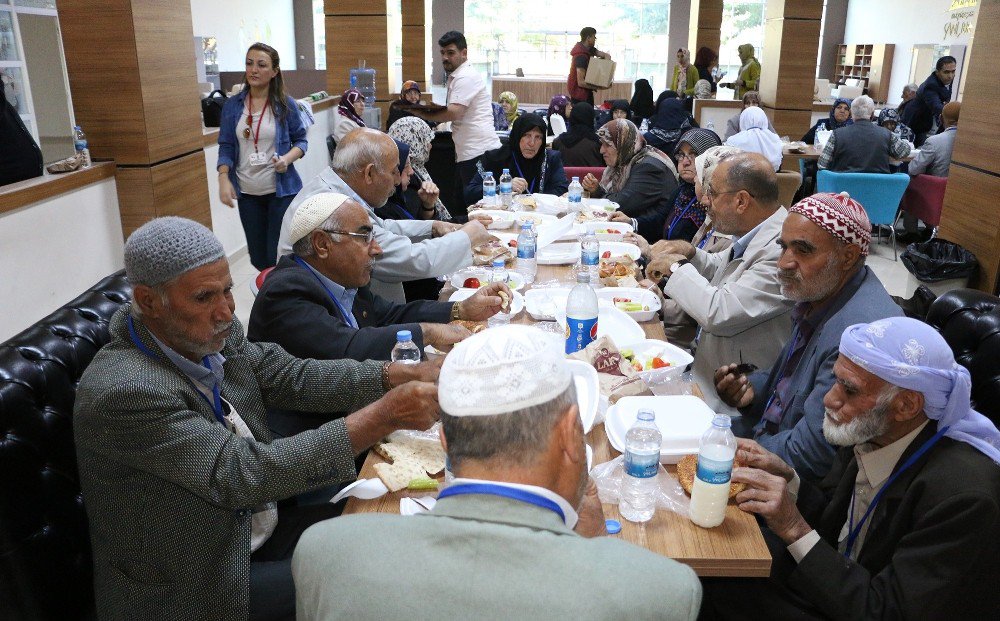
[758,19,820,110]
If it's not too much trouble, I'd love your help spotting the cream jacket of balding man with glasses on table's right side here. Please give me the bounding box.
[663,207,793,416]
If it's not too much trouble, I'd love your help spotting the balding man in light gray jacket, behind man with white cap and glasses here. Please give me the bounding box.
[278,128,490,303]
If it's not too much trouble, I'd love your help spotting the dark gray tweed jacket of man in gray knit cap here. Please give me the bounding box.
[73,305,383,621]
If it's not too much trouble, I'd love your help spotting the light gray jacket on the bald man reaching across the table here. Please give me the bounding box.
[278,166,472,304]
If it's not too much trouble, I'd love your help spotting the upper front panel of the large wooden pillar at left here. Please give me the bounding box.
[59,0,147,164]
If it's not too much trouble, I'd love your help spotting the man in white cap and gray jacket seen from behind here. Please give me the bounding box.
[292,325,701,621]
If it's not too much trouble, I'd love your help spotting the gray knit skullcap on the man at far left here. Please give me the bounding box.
[125,216,226,286]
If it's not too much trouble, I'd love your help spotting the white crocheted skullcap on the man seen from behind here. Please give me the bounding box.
[438,325,573,416]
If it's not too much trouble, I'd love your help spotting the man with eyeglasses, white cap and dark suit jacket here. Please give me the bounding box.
[247,192,512,437]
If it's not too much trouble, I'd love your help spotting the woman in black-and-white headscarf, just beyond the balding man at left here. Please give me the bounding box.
[388,116,451,220]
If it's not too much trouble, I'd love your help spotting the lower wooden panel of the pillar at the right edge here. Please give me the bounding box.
[938,166,1000,294]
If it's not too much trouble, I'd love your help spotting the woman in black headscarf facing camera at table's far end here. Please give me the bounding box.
[465,114,575,204]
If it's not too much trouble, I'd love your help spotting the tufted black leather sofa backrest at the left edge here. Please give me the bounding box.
[0,272,131,621]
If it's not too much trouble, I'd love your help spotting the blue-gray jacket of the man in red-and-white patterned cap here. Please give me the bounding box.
[743,266,903,481]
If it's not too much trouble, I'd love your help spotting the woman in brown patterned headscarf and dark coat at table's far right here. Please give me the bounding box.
[581,119,677,241]
